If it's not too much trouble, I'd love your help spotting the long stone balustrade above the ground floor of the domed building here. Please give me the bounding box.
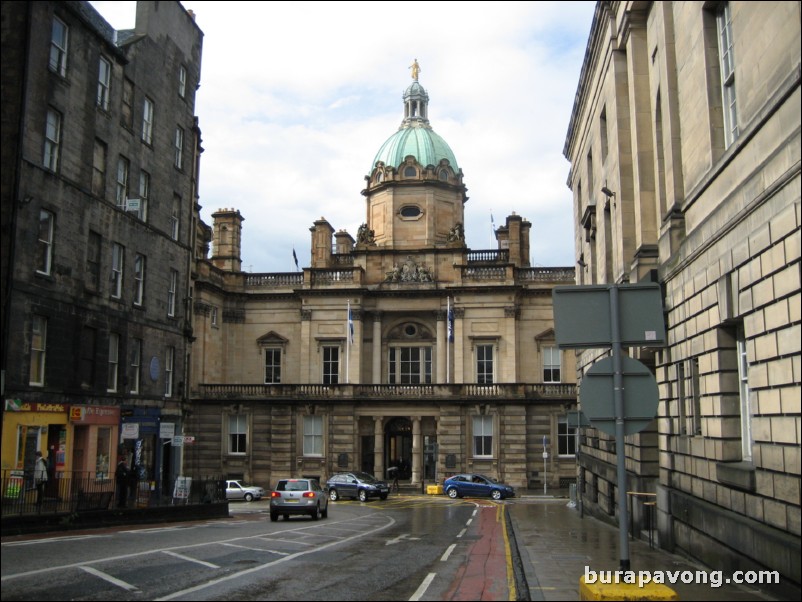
[198,383,576,401]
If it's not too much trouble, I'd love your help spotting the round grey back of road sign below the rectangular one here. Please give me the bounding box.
[579,356,658,435]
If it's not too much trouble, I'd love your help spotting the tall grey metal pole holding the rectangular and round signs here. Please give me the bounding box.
[610,285,630,571]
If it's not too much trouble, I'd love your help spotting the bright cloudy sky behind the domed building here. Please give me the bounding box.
[92,0,595,272]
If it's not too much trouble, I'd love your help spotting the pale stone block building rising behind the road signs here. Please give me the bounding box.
[564,2,802,593]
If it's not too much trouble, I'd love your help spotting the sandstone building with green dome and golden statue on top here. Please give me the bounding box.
[185,71,576,489]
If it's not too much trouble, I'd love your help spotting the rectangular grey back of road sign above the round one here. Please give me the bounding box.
[552,283,666,348]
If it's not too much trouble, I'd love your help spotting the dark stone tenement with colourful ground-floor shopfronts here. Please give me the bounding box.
[2,2,203,502]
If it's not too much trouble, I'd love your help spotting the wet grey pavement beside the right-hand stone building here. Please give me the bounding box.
[507,495,778,601]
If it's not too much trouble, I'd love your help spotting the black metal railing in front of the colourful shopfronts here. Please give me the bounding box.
[2,470,226,517]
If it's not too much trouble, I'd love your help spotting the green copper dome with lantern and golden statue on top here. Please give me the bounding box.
[370,73,459,171]
